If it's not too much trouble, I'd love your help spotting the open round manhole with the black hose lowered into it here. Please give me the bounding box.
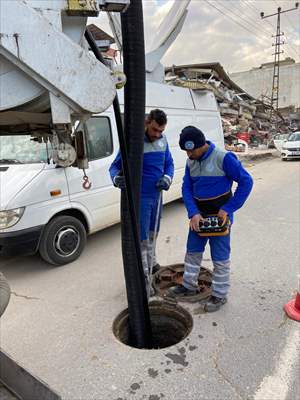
[113,301,193,349]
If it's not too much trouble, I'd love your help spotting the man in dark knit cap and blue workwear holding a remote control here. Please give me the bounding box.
[169,126,253,312]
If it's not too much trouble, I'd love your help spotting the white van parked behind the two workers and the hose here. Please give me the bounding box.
[0,82,224,265]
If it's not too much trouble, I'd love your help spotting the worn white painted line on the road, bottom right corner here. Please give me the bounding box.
[254,327,300,400]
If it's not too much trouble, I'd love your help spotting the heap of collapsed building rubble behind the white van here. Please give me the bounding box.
[165,63,296,151]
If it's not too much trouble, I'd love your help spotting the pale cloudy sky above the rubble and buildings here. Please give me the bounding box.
[89,0,300,73]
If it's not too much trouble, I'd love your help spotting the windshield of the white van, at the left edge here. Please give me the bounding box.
[0,135,51,164]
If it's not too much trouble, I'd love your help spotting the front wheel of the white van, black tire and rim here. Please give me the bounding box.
[39,215,86,265]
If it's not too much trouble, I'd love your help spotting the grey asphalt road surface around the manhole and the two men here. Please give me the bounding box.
[0,158,300,400]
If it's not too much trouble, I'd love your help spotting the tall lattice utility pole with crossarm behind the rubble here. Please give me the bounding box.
[260,2,299,130]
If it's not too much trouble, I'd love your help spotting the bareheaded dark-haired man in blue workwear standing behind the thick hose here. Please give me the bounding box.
[109,109,174,290]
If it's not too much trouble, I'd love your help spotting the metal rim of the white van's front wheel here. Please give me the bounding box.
[53,226,80,257]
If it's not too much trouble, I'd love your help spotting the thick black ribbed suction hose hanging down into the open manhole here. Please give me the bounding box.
[121,0,152,348]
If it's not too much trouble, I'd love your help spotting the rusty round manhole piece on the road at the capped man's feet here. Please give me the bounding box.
[153,264,212,303]
